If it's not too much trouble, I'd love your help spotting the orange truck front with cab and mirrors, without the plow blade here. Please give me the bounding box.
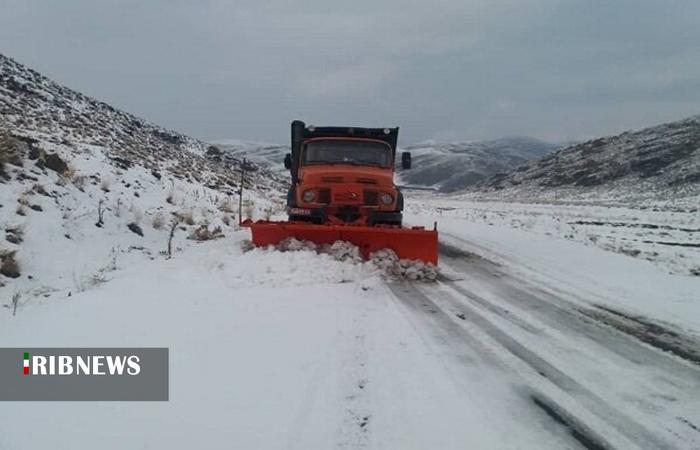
[284,120,411,226]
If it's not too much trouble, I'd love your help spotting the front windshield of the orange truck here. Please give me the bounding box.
[302,139,391,167]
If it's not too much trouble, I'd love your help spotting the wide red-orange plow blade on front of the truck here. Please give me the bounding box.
[244,221,438,265]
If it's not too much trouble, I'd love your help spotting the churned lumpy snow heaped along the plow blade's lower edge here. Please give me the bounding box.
[273,237,439,282]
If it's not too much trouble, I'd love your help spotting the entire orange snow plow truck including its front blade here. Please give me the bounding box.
[245,120,438,265]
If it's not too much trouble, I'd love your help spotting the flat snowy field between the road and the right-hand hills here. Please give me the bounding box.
[408,196,700,276]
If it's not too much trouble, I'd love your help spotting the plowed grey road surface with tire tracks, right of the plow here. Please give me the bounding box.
[391,234,700,449]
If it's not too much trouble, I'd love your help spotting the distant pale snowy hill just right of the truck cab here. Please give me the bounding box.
[401,137,557,192]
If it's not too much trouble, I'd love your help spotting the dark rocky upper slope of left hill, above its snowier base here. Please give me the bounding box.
[0,54,278,193]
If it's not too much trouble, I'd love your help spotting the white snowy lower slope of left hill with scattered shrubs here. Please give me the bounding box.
[0,139,279,307]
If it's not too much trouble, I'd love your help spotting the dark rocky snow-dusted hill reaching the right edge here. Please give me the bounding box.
[478,116,700,200]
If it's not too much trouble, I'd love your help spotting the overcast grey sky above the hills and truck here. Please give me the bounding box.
[0,0,700,144]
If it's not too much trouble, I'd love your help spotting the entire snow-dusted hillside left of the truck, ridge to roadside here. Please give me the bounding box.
[0,55,281,303]
